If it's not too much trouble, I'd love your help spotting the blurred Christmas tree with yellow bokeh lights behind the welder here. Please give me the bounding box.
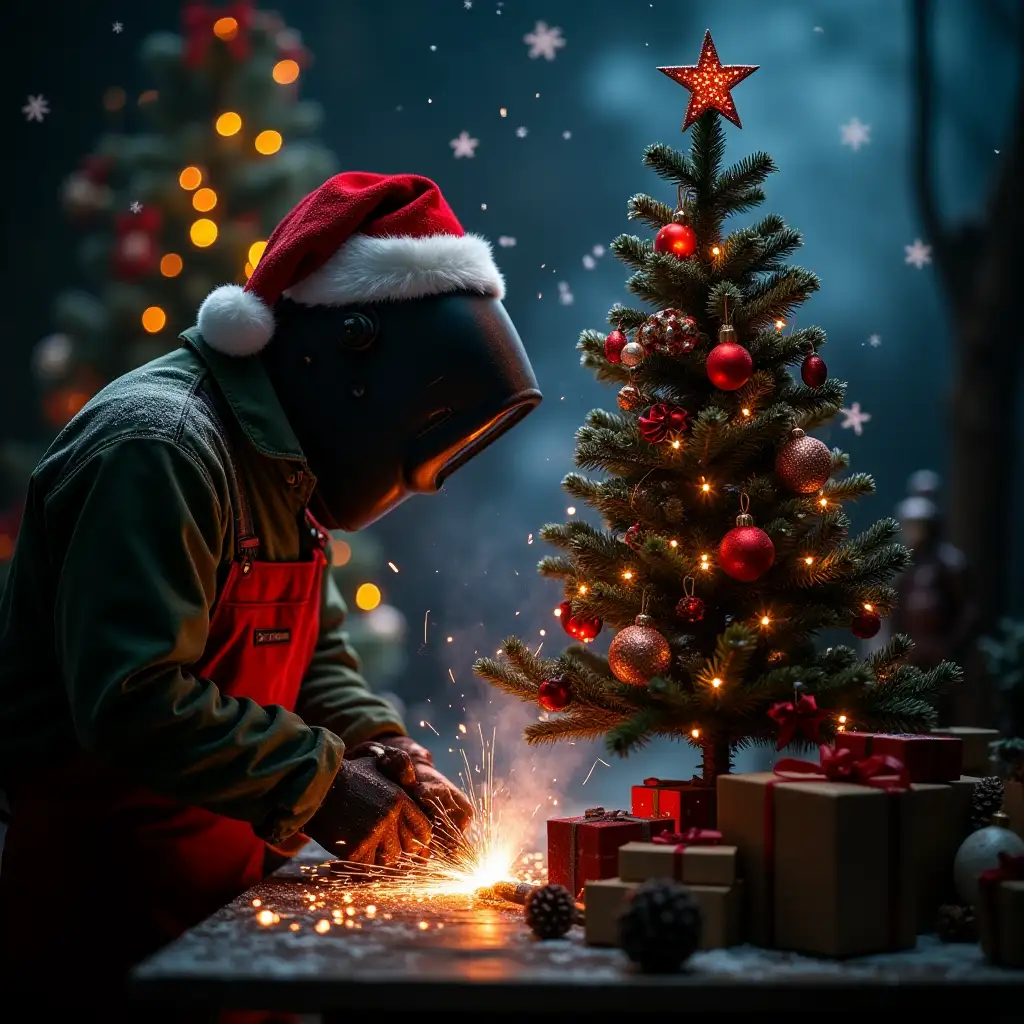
[0,0,336,582]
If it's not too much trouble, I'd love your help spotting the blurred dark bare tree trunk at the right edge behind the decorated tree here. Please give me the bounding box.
[911,0,1024,724]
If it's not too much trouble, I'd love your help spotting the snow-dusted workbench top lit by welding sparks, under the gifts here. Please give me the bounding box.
[130,857,1024,1022]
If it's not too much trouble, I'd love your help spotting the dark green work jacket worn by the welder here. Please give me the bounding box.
[0,329,404,842]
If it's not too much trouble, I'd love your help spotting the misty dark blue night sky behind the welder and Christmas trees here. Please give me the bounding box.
[0,0,1019,801]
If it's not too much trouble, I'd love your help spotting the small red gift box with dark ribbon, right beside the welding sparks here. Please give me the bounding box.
[548,807,672,898]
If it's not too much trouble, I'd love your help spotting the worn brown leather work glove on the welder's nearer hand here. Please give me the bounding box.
[302,751,431,867]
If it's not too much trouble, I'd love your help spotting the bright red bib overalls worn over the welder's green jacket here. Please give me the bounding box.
[0,446,327,989]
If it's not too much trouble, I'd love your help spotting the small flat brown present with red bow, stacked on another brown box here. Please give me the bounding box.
[618,828,736,886]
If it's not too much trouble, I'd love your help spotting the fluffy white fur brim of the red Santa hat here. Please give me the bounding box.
[285,234,505,306]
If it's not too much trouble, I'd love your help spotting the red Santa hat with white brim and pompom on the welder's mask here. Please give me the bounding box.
[199,171,505,356]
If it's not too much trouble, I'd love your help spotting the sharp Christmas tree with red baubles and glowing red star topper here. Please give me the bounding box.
[475,33,959,785]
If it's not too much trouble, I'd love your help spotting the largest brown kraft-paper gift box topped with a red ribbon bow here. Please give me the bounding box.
[718,746,921,956]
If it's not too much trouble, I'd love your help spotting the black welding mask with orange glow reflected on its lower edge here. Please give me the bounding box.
[261,293,541,530]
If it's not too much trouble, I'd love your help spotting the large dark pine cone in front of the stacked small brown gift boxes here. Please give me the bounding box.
[618,879,702,974]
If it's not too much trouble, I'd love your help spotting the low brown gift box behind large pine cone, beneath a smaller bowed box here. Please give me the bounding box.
[584,879,742,949]
